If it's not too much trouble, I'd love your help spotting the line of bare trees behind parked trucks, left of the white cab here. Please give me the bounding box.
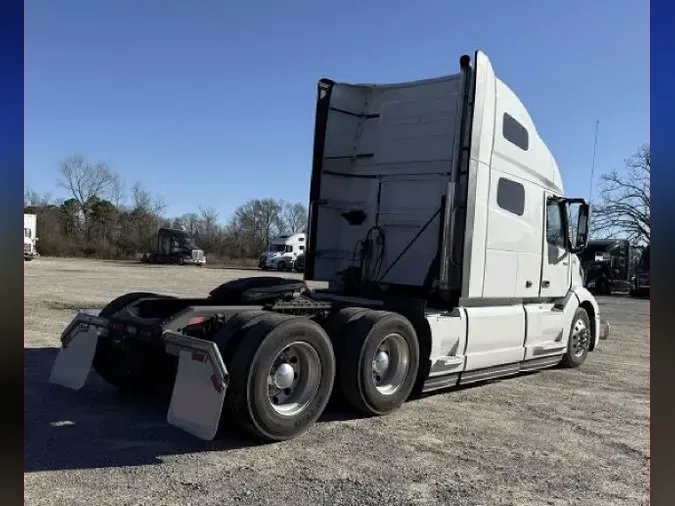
[24,155,307,262]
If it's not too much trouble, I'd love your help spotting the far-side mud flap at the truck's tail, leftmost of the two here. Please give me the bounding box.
[49,313,108,390]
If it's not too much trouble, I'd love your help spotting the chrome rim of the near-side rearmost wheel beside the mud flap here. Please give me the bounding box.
[267,341,321,416]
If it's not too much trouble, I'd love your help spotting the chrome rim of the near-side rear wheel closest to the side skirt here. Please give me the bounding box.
[371,333,410,395]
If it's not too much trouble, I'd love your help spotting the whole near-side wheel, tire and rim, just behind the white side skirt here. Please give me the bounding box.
[338,311,420,416]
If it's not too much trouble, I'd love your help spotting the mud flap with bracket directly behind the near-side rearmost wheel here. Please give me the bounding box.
[163,332,229,441]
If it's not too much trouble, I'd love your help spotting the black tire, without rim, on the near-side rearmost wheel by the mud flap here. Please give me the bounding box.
[226,313,335,442]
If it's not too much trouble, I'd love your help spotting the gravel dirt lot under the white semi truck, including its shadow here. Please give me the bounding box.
[25,258,649,506]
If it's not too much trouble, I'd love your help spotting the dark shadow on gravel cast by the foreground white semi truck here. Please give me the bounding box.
[24,348,354,472]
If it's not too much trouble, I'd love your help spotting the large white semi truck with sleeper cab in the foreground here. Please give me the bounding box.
[51,51,609,441]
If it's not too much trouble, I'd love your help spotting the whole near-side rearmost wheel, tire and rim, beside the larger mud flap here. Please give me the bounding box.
[227,313,335,442]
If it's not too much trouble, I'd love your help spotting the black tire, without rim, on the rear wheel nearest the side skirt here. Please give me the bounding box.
[338,311,420,416]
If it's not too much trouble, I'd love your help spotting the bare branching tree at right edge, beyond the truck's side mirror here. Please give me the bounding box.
[591,144,651,243]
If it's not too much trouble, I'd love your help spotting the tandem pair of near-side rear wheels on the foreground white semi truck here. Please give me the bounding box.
[214,308,419,441]
